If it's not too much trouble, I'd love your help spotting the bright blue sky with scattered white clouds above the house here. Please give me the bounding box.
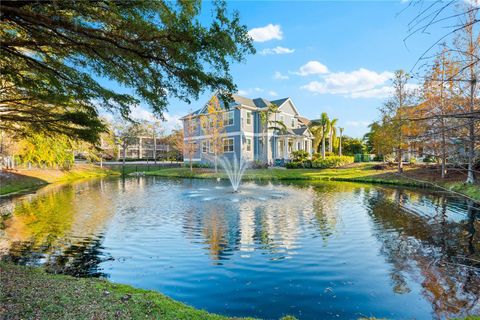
[106,1,454,137]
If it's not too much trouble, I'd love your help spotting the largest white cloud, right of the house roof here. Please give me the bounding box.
[301,68,393,98]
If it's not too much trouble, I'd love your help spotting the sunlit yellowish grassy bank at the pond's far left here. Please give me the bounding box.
[0,164,119,195]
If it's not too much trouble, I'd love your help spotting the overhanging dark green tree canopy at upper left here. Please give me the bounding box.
[0,0,255,141]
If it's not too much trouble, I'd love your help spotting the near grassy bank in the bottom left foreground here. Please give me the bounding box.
[0,263,255,320]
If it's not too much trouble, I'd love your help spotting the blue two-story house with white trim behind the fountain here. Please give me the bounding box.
[181,95,313,164]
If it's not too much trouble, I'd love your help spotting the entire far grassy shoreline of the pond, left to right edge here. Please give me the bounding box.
[0,163,480,202]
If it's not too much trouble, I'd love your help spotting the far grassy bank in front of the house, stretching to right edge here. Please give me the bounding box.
[145,163,480,201]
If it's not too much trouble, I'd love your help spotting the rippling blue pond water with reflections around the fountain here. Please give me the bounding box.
[0,177,480,319]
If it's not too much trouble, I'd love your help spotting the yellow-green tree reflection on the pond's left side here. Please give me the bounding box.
[0,180,113,276]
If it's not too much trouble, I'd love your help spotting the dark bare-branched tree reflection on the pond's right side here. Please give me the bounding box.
[364,189,480,319]
